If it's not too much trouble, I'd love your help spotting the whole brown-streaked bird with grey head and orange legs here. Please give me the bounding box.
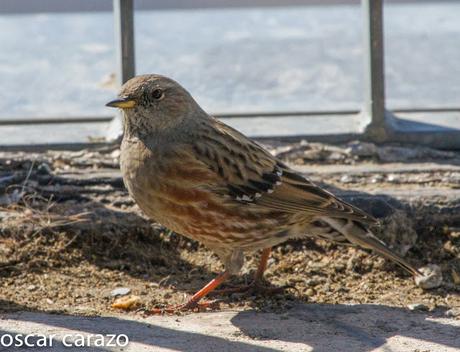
[106,74,420,312]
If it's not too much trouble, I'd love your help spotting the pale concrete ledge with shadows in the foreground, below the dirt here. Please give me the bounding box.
[0,304,460,352]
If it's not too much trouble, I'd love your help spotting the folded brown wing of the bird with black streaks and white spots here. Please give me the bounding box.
[193,120,377,224]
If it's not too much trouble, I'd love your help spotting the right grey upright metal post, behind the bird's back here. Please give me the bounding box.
[361,0,385,140]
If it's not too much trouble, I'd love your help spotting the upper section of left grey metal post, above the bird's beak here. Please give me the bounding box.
[113,0,135,85]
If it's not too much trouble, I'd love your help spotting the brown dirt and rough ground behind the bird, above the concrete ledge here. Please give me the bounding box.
[0,143,460,315]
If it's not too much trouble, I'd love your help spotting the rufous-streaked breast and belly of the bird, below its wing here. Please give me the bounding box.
[120,136,294,248]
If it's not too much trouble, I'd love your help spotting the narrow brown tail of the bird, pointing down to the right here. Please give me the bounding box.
[321,217,421,276]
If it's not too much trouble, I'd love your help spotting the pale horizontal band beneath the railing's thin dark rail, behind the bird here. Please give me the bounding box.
[0,111,460,150]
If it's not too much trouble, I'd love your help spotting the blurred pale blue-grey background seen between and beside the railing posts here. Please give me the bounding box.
[0,0,460,119]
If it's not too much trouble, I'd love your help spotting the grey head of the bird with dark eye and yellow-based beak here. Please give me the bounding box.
[106,75,203,135]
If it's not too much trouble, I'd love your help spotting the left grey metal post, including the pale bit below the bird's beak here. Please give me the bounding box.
[106,0,135,142]
